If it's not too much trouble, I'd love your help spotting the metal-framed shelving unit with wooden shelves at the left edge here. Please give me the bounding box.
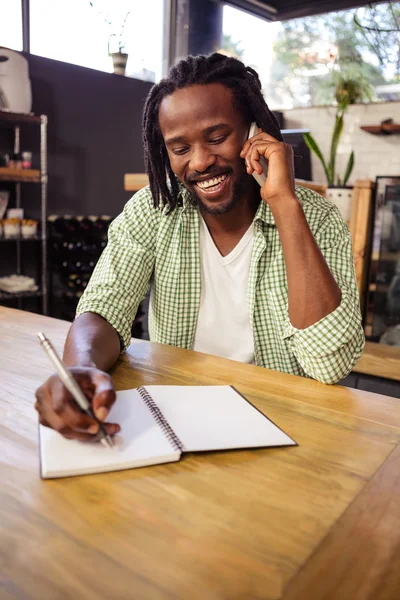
[0,111,48,315]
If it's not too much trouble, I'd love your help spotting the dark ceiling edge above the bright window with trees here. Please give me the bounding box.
[224,0,387,21]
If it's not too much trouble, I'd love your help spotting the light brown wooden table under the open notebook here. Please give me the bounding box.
[0,308,400,600]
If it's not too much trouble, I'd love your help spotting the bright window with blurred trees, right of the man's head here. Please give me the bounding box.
[223,2,400,109]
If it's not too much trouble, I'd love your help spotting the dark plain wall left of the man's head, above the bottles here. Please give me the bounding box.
[22,55,152,216]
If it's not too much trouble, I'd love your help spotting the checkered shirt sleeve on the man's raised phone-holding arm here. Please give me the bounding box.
[283,207,365,384]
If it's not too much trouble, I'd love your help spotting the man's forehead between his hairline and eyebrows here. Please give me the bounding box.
[158,83,243,137]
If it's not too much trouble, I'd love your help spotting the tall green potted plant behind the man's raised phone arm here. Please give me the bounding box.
[304,72,371,222]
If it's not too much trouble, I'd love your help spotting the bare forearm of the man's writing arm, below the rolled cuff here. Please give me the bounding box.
[64,312,120,371]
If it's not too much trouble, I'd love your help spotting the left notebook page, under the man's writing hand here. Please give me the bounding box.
[40,390,181,478]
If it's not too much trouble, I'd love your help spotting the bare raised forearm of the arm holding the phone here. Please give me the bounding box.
[272,196,341,329]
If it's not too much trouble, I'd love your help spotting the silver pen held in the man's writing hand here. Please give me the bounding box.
[38,333,114,448]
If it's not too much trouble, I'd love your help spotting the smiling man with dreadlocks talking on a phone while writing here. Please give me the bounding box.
[36,54,364,440]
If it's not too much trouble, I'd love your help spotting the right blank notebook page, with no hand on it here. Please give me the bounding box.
[145,385,296,452]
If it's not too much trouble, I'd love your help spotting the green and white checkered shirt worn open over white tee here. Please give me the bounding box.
[77,187,364,383]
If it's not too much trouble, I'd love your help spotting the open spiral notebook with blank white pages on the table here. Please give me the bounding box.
[39,385,296,479]
